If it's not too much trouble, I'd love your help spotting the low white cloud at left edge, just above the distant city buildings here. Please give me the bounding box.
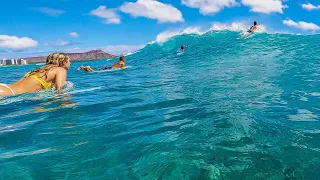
[0,35,38,50]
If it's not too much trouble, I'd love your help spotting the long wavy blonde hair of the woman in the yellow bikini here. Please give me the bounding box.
[29,52,69,78]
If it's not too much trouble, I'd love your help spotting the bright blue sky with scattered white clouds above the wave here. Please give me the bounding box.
[0,0,320,59]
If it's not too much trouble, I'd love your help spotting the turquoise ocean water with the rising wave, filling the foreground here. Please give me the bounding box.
[0,31,320,180]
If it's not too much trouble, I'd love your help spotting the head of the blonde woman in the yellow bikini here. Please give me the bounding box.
[46,53,71,70]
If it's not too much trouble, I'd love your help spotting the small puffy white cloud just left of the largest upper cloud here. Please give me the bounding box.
[90,6,121,24]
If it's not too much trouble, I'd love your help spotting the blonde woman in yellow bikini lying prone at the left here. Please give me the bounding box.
[0,53,71,96]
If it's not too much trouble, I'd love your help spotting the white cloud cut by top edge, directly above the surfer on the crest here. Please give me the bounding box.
[242,0,288,14]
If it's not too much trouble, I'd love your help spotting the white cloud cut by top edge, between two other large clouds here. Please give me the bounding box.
[181,0,237,15]
